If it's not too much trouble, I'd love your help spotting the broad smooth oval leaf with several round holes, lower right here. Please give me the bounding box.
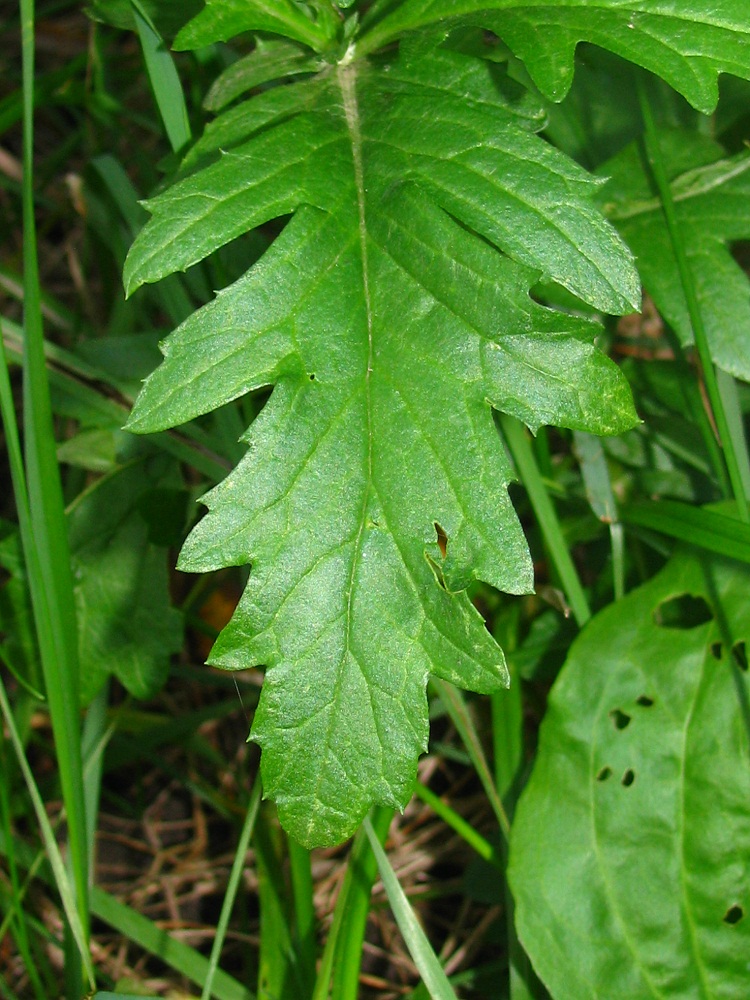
[509,528,750,1000]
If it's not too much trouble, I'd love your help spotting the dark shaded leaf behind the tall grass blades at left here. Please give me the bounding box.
[68,462,182,703]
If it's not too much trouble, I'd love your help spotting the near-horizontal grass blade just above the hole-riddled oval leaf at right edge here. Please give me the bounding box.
[620,500,750,562]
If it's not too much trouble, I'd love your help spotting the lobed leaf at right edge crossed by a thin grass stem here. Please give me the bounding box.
[597,131,750,381]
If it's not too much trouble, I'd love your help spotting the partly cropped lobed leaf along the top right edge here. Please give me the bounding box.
[356,0,750,113]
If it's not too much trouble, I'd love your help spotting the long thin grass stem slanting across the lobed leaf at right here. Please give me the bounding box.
[636,73,750,521]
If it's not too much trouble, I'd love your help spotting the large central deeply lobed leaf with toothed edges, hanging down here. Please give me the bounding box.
[126,35,639,844]
